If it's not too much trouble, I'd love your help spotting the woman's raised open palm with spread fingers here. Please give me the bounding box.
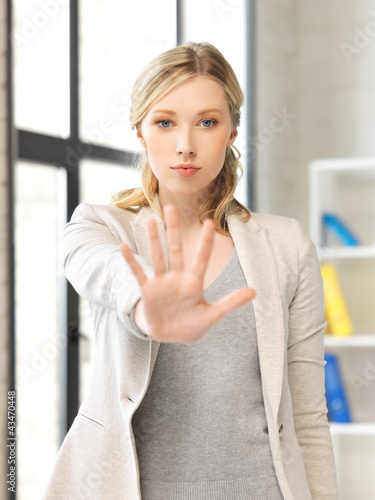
[121,205,255,344]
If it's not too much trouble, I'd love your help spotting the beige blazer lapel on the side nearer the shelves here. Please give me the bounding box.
[228,214,285,423]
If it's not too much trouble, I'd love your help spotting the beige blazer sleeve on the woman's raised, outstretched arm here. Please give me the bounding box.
[58,203,154,340]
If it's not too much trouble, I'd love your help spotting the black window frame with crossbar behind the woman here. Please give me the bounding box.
[6,0,256,500]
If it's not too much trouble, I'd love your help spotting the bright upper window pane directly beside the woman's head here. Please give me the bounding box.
[80,0,176,151]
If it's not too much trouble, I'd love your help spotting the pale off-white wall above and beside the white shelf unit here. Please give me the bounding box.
[256,0,375,229]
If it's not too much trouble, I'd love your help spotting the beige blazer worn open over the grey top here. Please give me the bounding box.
[44,198,338,500]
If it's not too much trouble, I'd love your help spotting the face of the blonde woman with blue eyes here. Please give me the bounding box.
[137,76,237,206]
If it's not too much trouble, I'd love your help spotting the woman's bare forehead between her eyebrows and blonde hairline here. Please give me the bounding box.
[149,76,229,114]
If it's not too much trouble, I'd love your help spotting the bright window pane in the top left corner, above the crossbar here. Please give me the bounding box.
[12,0,70,137]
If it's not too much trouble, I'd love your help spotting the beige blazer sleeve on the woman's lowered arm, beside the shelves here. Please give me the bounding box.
[287,219,339,500]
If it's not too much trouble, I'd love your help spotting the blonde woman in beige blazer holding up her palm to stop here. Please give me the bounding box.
[45,43,338,500]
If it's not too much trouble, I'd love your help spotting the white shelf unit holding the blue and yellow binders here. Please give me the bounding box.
[309,157,375,500]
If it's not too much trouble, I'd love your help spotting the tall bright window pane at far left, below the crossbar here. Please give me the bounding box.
[15,162,64,500]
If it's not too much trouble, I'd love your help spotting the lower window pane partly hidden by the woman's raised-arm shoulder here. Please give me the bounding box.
[80,160,140,401]
